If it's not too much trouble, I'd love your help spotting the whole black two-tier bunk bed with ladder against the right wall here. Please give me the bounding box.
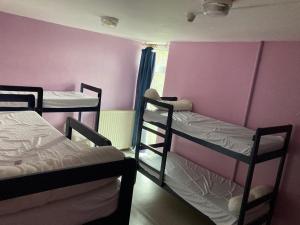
[135,97,292,225]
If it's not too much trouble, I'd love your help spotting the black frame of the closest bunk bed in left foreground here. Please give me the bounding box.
[0,94,137,225]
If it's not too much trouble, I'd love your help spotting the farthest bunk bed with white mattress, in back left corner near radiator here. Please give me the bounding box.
[0,83,102,131]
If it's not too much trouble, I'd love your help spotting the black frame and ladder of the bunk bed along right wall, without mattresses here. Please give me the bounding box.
[135,97,293,225]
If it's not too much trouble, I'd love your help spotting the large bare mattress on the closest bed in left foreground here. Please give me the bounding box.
[0,111,124,215]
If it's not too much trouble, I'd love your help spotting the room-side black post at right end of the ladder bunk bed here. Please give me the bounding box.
[238,128,261,225]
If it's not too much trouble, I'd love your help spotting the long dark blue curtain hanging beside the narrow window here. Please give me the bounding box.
[132,47,155,147]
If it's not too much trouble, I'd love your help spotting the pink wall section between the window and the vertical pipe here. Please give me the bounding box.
[164,43,259,177]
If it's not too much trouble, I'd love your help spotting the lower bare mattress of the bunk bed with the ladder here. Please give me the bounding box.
[140,151,268,225]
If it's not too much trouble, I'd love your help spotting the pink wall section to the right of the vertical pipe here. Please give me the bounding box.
[239,42,300,225]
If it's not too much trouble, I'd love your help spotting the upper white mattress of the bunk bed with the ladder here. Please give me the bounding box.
[144,110,284,156]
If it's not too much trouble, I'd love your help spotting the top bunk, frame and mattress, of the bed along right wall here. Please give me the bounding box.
[140,97,292,164]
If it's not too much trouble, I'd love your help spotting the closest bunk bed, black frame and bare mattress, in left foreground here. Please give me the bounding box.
[0,94,137,225]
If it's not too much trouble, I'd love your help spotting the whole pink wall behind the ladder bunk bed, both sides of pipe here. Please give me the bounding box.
[164,42,300,225]
